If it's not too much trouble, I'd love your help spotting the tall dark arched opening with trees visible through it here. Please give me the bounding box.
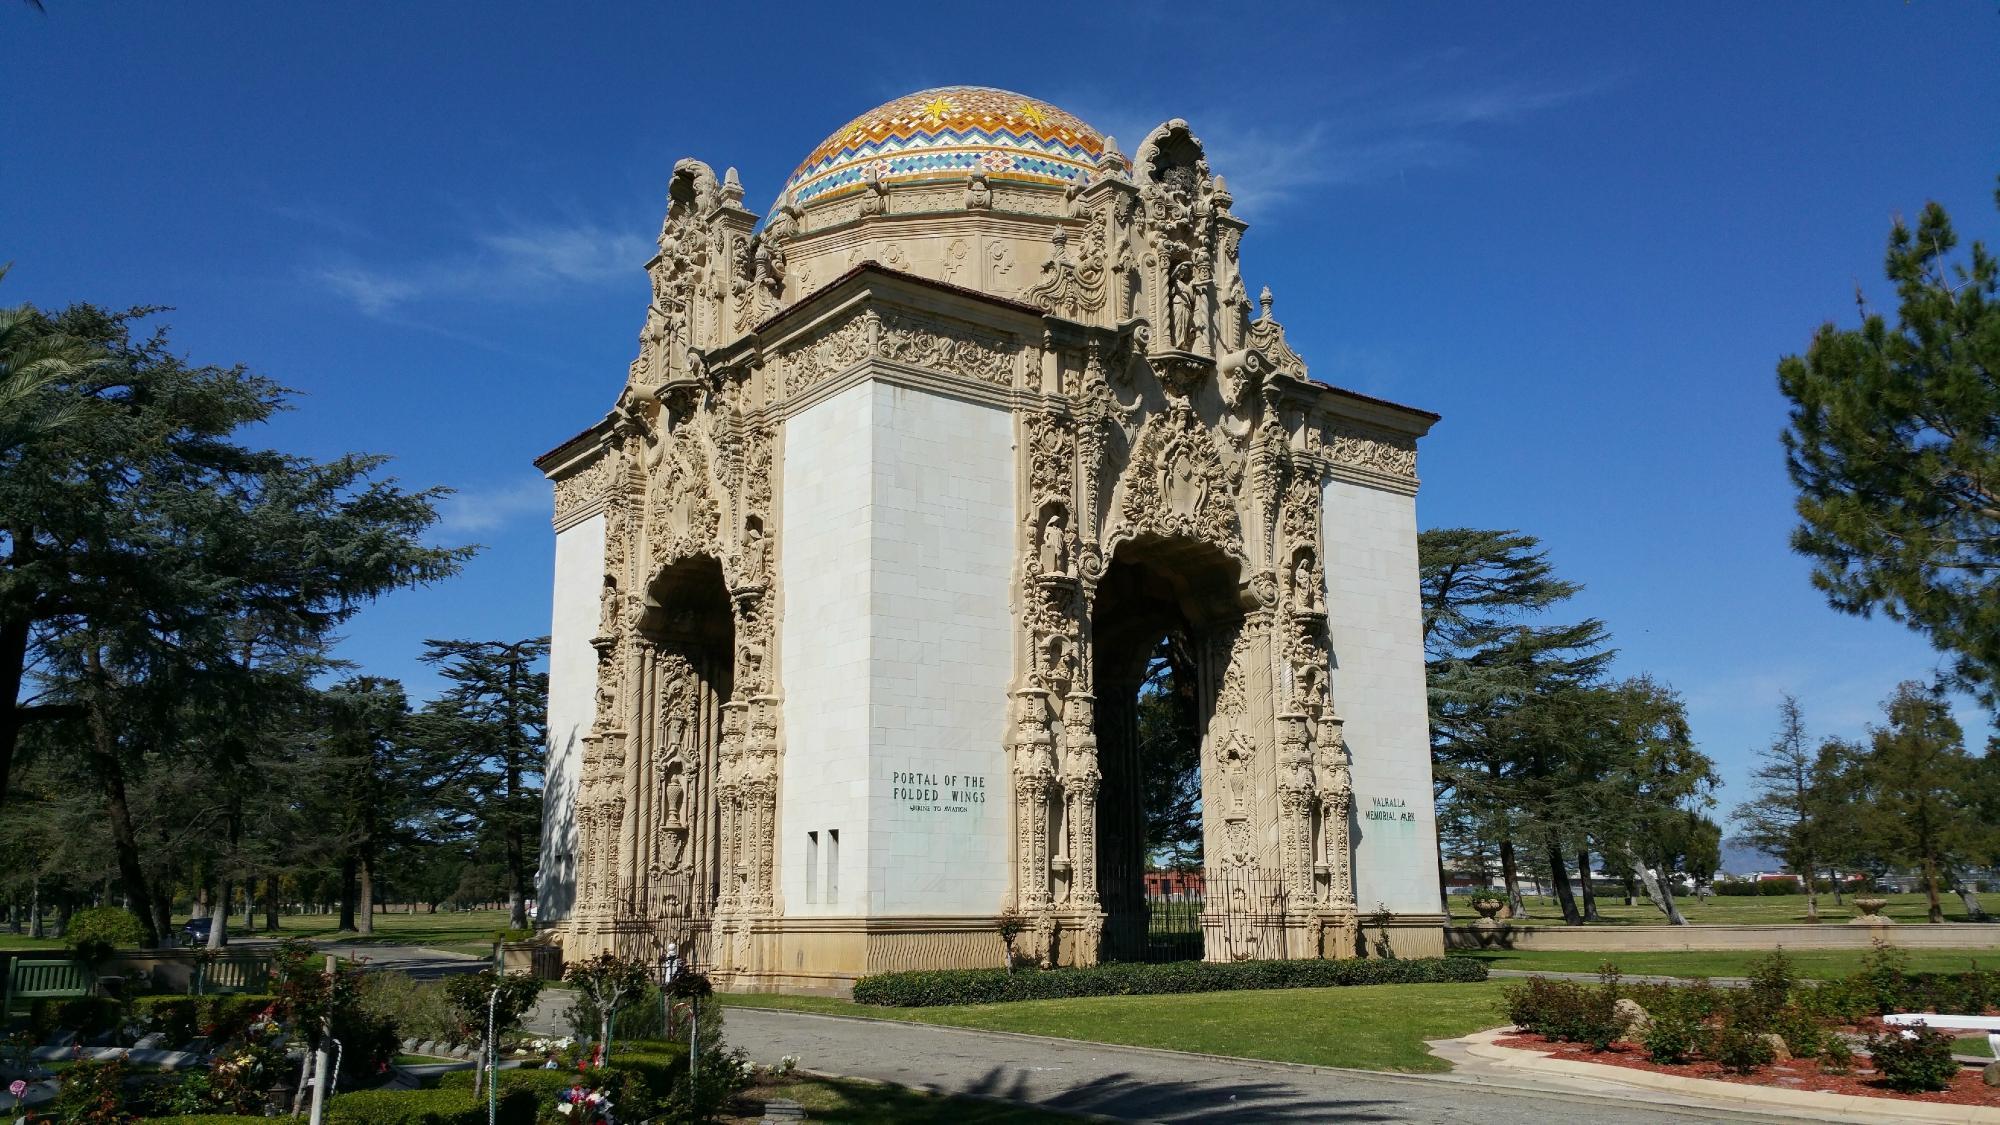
[1090,538,1242,961]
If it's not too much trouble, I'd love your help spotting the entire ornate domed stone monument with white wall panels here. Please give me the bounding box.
[538,86,1444,987]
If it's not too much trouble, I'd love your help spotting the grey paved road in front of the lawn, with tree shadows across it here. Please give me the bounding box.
[726,1007,1800,1125]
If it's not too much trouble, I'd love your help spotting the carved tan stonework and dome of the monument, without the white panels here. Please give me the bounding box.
[538,88,1436,987]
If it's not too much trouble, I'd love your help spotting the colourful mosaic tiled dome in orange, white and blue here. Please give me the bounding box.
[784,86,1104,206]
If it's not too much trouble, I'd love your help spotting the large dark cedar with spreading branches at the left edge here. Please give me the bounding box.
[0,306,468,941]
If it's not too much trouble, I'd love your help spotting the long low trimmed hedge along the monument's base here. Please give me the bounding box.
[848,957,1486,1000]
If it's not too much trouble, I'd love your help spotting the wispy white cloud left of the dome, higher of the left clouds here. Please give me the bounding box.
[306,222,652,316]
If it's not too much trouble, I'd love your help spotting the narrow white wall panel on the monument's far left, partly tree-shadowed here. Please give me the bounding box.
[536,514,604,923]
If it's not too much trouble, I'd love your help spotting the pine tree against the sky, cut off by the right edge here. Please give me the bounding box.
[1778,179,2000,701]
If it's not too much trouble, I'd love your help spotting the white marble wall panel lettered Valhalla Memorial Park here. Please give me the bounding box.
[1322,480,1440,915]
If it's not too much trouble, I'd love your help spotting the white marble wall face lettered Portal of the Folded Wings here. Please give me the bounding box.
[868,382,1016,915]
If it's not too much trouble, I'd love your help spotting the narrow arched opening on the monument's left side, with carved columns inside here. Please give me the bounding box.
[626,554,736,953]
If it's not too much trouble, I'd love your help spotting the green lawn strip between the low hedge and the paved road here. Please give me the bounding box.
[724,981,1506,1071]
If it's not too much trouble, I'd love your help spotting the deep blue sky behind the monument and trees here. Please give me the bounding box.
[0,0,2000,803]
